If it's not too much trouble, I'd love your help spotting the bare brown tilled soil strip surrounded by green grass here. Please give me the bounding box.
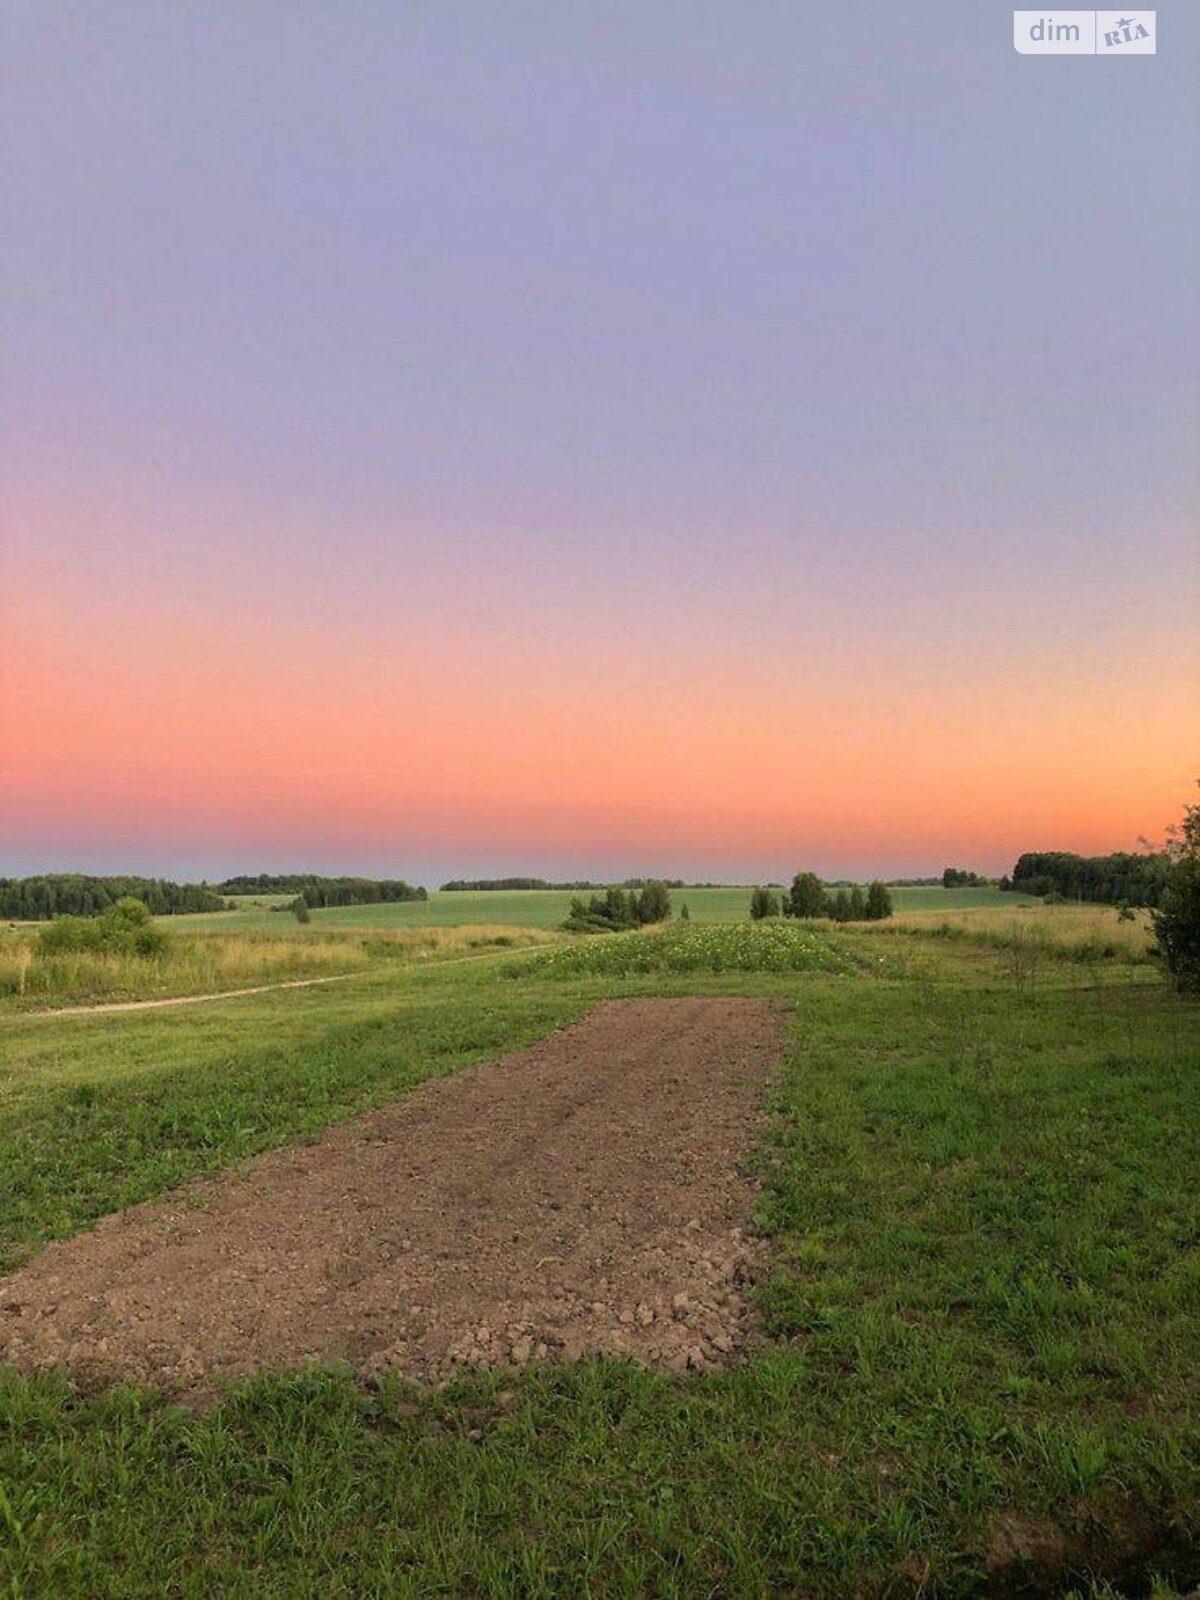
[0,1000,781,1394]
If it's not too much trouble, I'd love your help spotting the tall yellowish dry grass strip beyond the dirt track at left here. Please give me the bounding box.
[0,925,552,1008]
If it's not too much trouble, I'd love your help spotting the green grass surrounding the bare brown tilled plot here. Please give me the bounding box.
[0,933,1200,1597]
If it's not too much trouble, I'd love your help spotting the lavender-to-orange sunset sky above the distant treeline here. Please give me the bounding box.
[0,0,1200,883]
